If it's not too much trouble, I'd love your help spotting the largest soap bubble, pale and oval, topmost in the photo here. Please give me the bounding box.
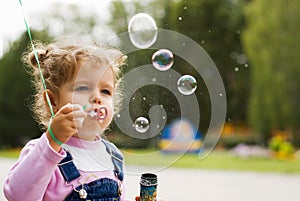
[128,13,157,49]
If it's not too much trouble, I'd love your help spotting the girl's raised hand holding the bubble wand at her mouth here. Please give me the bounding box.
[46,103,86,151]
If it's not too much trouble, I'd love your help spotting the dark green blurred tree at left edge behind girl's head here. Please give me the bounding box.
[0,31,50,146]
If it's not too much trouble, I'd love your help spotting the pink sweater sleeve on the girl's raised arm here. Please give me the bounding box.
[3,134,66,201]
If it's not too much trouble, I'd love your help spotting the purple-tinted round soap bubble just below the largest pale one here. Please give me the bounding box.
[152,49,174,71]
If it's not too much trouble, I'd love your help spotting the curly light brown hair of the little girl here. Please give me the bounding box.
[22,40,127,130]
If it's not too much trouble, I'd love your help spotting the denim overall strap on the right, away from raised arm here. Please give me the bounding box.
[102,139,124,181]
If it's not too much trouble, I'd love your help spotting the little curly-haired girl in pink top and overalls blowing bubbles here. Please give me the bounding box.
[4,38,135,201]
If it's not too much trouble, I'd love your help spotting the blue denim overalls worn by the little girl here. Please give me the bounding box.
[58,139,124,201]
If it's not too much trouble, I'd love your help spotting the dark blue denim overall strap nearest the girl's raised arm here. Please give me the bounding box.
[58,151,80,183]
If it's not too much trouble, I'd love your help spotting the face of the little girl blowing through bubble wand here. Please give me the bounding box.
[57,61,115,140]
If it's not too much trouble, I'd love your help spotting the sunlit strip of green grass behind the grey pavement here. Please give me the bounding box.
[0,149,300,174]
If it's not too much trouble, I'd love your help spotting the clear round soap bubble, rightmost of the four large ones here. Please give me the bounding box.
[177,75,197,95]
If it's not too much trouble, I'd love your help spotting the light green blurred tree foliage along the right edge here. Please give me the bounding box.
[243,0,300,144]
